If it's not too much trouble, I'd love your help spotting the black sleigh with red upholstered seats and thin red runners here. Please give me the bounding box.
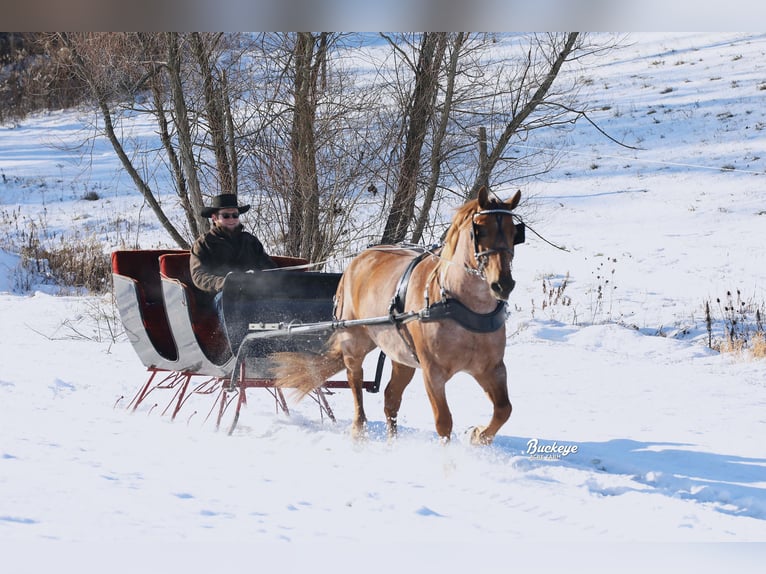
[111,250,382,433]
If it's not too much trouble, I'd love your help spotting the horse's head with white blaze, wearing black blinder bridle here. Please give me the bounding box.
[471,187,524,301]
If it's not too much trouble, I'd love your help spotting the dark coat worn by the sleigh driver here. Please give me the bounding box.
[189,225,277,294]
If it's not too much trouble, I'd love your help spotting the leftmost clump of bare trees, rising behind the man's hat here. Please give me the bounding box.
[56,32,260,247]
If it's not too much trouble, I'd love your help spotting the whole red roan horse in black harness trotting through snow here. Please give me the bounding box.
[271,188,524,445]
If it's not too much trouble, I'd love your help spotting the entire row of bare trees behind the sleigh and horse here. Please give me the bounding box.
[40,32,616,261]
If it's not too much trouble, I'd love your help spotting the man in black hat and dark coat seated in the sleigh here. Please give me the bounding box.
[189,193,277,318]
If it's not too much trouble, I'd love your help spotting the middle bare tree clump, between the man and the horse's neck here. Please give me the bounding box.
[241,33,394,262]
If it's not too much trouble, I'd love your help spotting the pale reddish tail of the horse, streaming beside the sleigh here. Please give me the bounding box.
[270,335,344,400]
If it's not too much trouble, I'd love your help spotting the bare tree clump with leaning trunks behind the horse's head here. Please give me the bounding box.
[372,32,614,242]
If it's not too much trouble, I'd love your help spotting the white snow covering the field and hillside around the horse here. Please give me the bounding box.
[0,33,766,572]
